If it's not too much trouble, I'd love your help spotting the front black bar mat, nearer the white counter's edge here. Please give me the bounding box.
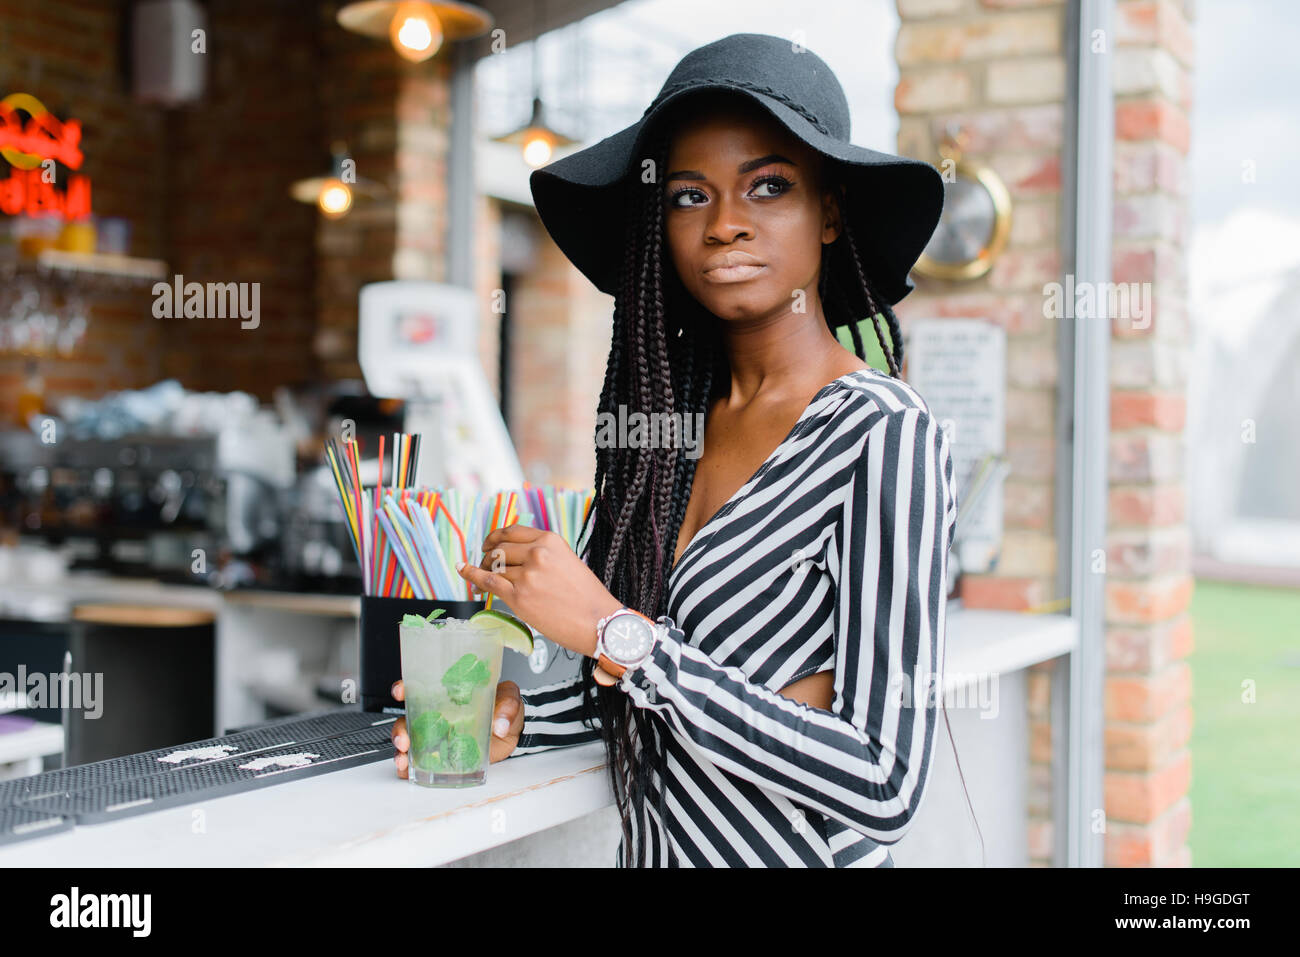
[22,726,394,824]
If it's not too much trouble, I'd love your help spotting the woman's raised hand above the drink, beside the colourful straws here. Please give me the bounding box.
[456,524,623,655]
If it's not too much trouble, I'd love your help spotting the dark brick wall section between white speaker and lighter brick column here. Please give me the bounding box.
[161,0,325,399]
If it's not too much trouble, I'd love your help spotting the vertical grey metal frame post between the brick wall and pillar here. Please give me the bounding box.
[1052,0,1114,867]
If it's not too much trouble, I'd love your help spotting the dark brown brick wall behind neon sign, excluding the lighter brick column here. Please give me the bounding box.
[0,0,324,408]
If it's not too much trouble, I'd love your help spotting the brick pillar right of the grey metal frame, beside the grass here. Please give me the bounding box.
[1105,0,1193,867]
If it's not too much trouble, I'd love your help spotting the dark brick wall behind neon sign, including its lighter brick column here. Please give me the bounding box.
[0,0,450,408]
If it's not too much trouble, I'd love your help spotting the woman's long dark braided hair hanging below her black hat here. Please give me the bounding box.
[569,128,977,866]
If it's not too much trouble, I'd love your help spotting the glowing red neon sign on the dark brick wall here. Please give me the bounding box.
[0,94,90,220]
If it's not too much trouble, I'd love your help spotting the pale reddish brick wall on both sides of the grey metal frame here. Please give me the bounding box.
[894,0,1192,866]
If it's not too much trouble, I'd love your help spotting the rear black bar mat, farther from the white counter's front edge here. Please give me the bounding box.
[0,709,397,807]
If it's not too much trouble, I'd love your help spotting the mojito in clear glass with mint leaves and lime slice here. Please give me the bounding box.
[399,615,504,788]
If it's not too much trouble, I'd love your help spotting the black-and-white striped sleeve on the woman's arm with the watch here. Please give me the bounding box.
[620,407,956,844]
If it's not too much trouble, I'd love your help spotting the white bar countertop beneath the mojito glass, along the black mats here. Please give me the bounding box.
[0,742,618,867]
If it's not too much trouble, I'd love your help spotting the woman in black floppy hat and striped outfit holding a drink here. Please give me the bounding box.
[394,34,957,867]
